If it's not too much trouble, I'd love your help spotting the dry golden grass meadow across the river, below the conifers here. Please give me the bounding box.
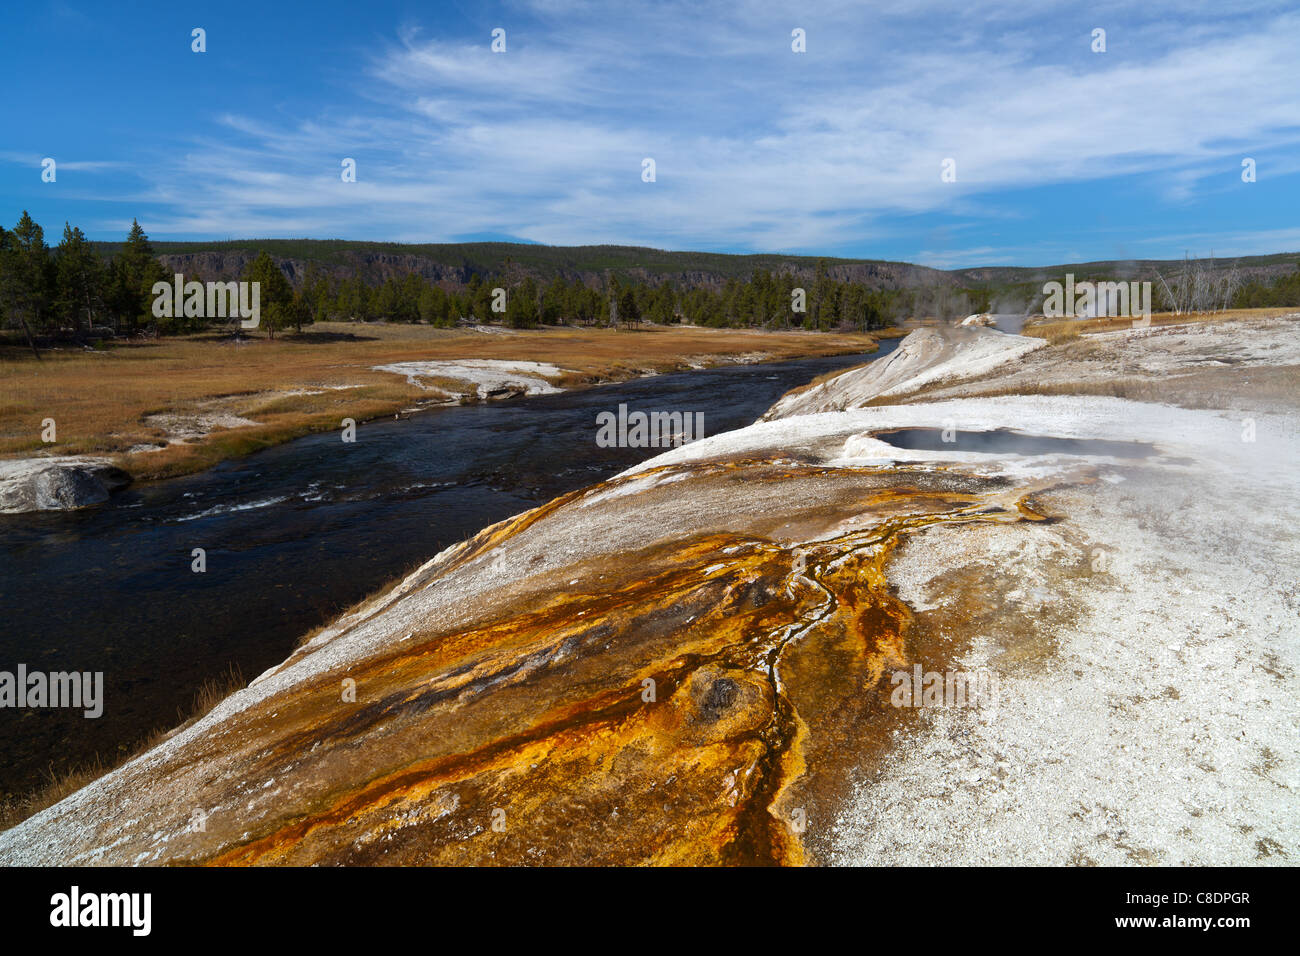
[0,323,875,479]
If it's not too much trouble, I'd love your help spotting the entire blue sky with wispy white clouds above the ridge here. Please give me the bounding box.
[0,0,1300,268]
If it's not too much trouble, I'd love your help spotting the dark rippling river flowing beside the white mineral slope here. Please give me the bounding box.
[0,339,898,796]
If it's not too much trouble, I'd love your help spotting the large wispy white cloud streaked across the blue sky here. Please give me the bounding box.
[12,0,1300,263]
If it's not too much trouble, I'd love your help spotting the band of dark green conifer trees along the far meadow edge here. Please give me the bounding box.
[0,211,1300,351]
